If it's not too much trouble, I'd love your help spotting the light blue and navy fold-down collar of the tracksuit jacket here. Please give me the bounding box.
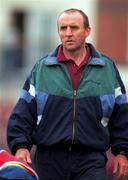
[44,43,105,66]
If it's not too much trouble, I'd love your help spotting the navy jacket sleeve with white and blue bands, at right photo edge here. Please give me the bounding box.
[109,65,128,155]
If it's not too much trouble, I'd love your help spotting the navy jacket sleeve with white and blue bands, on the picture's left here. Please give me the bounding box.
[7,68,37,154]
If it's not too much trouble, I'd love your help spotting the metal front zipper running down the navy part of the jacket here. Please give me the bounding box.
[69,89,77,151]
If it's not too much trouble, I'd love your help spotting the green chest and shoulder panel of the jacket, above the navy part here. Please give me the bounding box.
[31,53,118,98]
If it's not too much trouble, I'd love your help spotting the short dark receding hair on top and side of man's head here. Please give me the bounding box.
[58,8,90,27]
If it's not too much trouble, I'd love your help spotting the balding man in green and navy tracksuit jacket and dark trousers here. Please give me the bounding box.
[8,9,128,180]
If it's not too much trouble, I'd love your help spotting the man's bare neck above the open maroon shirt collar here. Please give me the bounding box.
[63,46,87,66]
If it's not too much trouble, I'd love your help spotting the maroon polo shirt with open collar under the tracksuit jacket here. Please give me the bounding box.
[57,45,90,90]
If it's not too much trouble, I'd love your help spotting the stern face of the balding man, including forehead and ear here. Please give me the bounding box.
[58,12,90,51]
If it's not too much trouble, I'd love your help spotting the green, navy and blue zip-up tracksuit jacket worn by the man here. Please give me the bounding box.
[8,44,128,155]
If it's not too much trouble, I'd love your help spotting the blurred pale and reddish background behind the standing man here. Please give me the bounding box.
[0,0,128,179]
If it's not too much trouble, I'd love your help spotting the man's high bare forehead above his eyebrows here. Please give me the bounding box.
[58,12,84,25]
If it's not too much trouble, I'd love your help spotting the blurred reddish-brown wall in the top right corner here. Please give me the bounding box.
[97,0,128,64]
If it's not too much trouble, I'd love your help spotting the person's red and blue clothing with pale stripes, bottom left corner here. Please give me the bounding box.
[0,148,38,180]
